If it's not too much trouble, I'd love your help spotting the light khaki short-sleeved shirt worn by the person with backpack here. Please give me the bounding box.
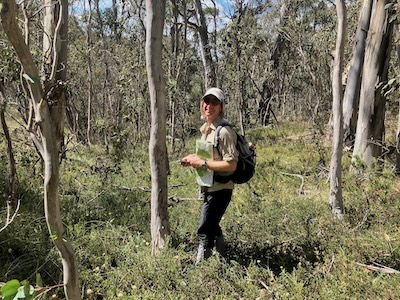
[200,117,239,192]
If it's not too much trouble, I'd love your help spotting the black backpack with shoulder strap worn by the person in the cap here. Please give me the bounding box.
[214,124,256,184]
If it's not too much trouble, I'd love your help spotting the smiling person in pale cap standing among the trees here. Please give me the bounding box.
[181,87,239,263]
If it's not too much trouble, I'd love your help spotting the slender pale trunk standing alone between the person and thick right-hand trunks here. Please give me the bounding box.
[329,0,346,217]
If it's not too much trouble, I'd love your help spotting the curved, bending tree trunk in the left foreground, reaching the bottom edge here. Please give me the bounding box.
[0,0,82,300]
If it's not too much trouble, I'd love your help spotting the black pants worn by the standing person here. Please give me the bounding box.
[197,189,232,248]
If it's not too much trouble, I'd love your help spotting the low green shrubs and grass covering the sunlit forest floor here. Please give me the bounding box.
[0,122,400,299]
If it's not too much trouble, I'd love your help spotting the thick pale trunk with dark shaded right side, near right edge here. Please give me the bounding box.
[353,0,393,168]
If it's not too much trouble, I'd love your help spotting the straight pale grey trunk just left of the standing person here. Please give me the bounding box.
[146,0,170,254]
